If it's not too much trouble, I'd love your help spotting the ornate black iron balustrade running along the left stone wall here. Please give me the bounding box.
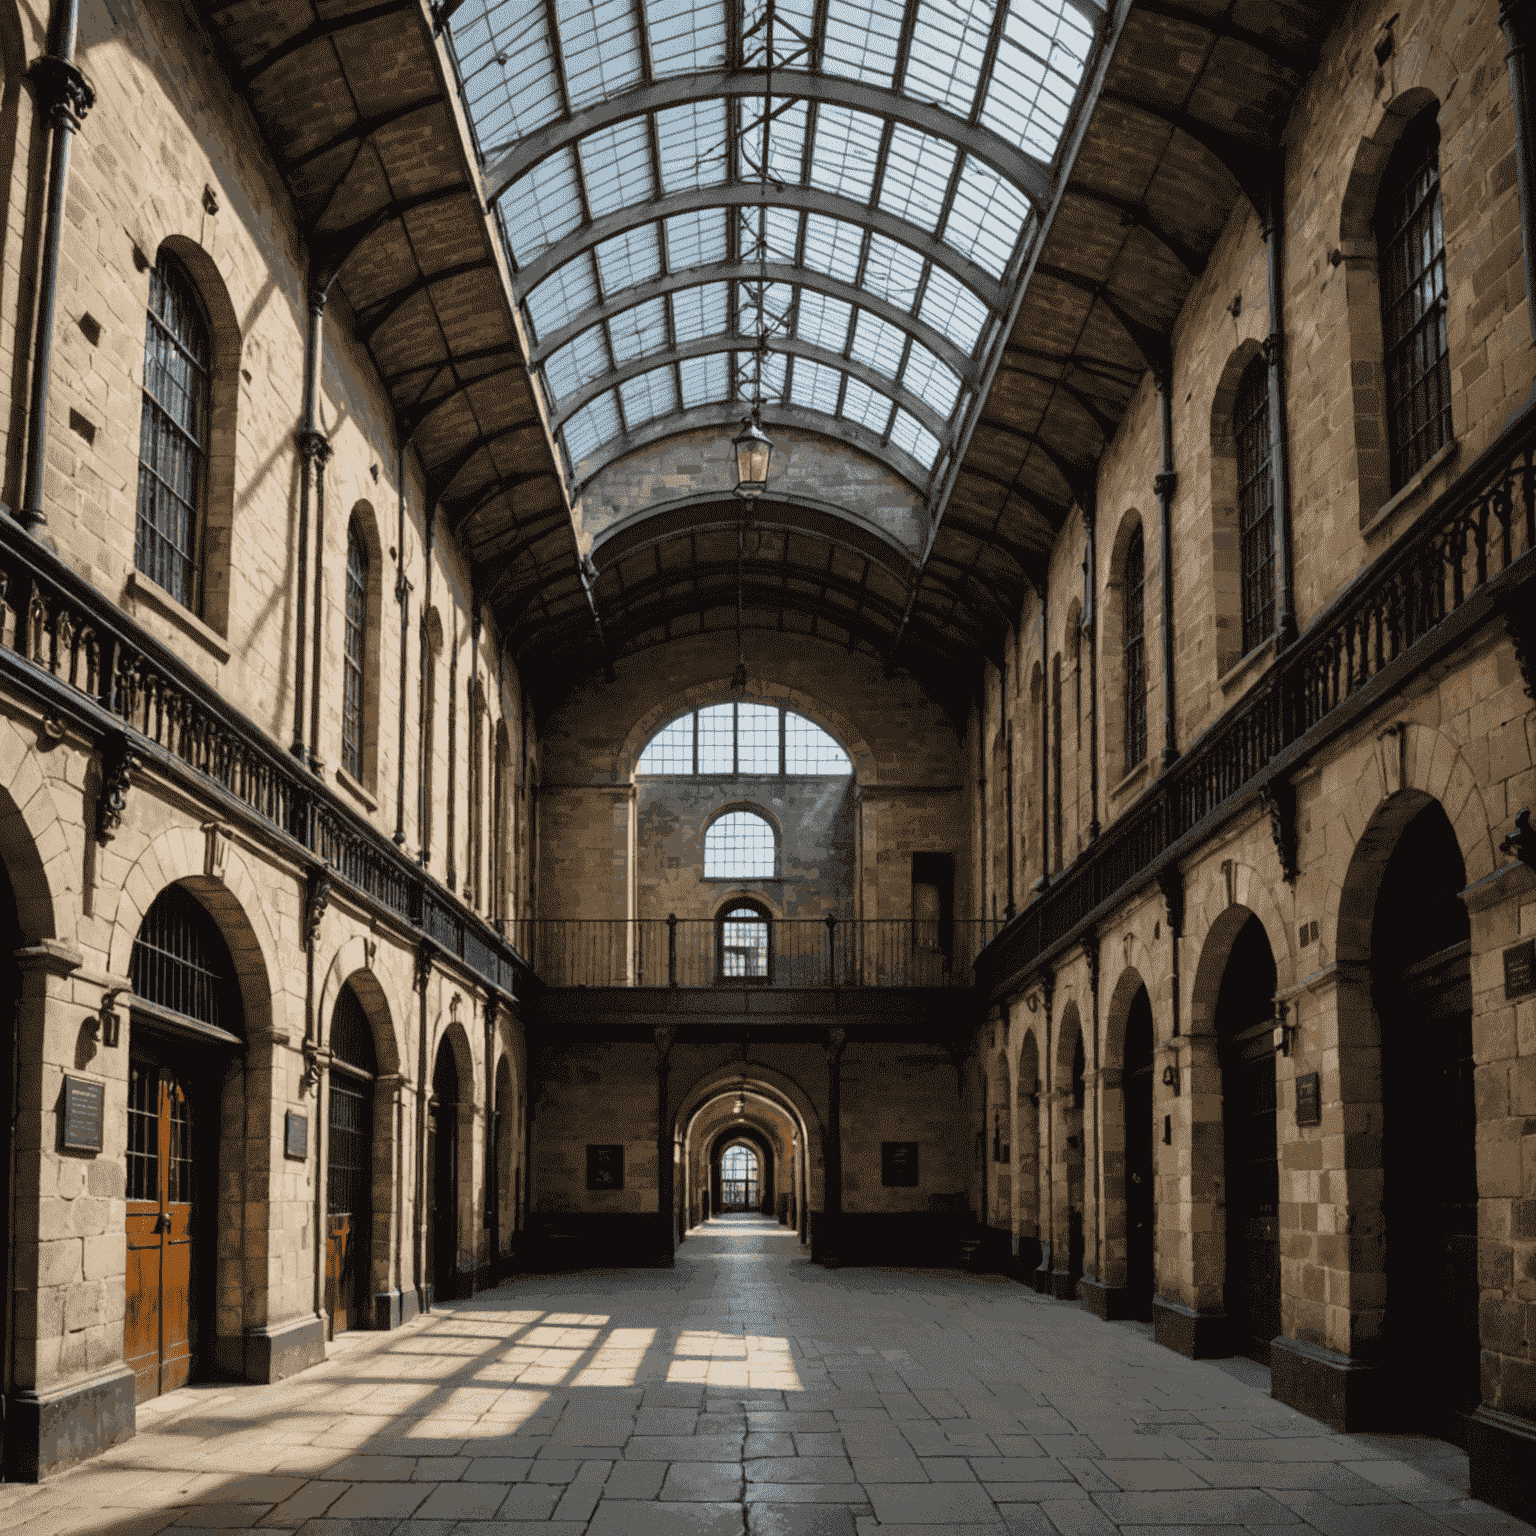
[0,518,528,994]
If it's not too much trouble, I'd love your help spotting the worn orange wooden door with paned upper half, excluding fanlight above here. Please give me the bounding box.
[123,1061,197,1402]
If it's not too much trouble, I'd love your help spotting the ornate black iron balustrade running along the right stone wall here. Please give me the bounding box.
[975,409,1536,997]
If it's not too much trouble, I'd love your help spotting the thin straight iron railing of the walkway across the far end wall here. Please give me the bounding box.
[515,914,998,988]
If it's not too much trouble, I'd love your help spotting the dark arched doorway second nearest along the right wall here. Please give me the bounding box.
[1217,912,1279,1364]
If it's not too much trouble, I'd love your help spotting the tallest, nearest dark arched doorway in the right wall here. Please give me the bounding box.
[1372,800,1481,1445]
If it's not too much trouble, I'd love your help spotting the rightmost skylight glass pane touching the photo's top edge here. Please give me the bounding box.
[982,0,1092,160]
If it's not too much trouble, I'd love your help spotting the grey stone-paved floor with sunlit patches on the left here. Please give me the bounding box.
[0,1218,1531,1536]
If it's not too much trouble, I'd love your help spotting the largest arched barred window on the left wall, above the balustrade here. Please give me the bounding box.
[134,252,212,608]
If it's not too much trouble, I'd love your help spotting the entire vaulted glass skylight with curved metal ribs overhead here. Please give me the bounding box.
[439,0,1100,492]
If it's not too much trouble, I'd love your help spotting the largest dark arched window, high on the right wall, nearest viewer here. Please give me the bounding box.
[1376,106,1452,492]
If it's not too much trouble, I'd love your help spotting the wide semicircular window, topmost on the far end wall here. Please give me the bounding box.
[636,703,854,774]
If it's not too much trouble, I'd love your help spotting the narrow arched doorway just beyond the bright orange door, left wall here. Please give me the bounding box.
[326,986,378,1338]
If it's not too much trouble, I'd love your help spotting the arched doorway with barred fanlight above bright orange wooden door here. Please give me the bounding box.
[123,885,244,1402]
